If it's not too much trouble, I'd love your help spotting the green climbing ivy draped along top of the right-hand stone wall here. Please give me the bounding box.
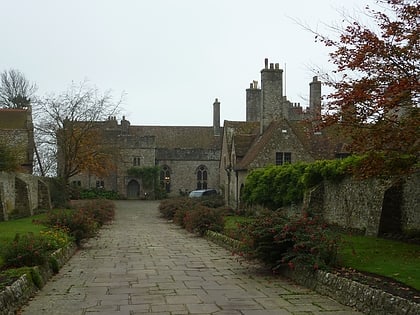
[242,153,419,209]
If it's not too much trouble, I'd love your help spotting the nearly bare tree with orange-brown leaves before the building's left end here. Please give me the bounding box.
[35,82,123,183]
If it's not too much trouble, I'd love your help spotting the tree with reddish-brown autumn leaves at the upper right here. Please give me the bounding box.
[315,0,420,173]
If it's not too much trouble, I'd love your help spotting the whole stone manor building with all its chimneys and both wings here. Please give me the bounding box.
[72,59,340,202]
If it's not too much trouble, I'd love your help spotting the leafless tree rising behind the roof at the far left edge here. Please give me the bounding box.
[0,69,37,108]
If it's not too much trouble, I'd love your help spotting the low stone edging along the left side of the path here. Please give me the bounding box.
[0,243,77,315]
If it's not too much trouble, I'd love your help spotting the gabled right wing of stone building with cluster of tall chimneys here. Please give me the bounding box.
[220,59,344,208]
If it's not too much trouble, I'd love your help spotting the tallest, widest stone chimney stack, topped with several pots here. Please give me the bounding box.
[260,58,287,133]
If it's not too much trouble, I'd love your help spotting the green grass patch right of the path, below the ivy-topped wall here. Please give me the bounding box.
[339,235,420,290]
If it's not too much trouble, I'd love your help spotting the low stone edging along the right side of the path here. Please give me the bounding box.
[205,231,420,315]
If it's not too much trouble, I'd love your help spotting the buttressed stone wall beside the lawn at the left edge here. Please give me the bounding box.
[0,172,51,221]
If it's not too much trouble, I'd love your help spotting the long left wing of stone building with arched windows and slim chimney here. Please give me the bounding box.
[71,99,222,199]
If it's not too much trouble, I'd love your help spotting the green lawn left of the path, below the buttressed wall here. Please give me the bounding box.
[0,214,46,266]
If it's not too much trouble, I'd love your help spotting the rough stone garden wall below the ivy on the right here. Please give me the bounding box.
[304,173,420,236]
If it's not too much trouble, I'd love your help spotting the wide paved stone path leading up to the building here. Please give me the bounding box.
[22,201,361,315]
